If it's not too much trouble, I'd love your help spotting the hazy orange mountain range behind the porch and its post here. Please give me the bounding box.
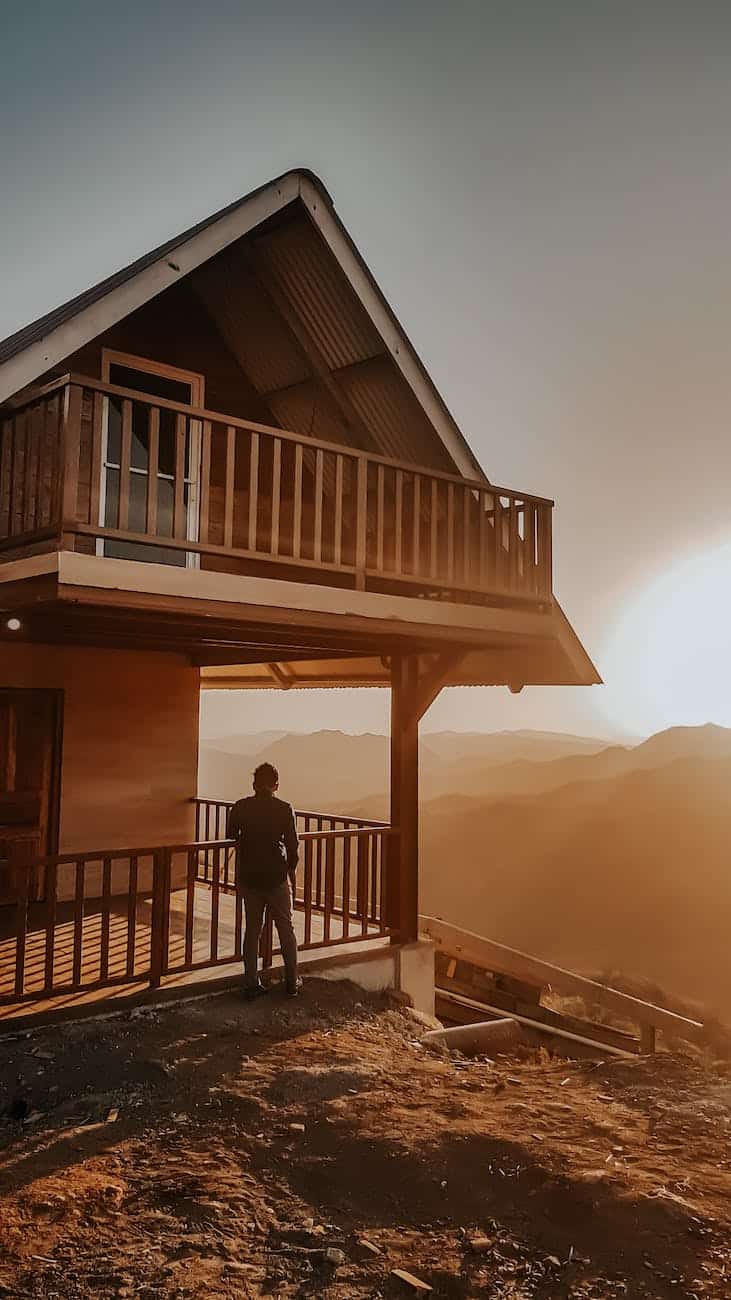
[200,724,731,1018]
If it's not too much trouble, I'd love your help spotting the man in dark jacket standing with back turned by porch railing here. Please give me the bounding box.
[226,763,302,998]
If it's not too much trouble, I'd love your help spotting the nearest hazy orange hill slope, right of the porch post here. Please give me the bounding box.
[421,755,731,1015]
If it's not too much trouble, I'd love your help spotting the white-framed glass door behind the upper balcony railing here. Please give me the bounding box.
[98,348,203,568]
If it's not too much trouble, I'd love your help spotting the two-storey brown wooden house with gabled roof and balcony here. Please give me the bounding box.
[0,172,598,1001]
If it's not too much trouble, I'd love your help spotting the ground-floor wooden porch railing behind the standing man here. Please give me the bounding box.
[0,824,397,1009]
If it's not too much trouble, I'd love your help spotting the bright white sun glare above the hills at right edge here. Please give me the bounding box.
[597,545,731,735]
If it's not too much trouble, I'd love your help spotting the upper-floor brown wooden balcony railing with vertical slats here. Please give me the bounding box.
[0,374,553,602]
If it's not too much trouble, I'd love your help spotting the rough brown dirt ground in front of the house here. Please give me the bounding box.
[0,982,731,1300]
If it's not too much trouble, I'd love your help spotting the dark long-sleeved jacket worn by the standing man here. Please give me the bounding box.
[226,790,299,889]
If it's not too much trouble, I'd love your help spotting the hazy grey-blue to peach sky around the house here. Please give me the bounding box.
[0,0,731,731]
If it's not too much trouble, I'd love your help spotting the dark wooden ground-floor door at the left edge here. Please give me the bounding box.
[0,690,61,902]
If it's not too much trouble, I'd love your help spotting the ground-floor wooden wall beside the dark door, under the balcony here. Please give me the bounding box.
[0,645,199,878]
